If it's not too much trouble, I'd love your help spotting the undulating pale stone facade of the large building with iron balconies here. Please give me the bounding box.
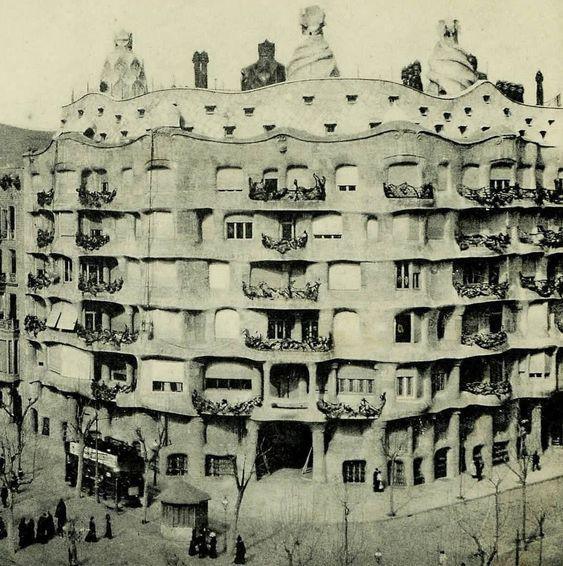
[19,79,563,490]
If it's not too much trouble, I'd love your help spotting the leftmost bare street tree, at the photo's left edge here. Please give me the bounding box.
[0,422,36,553]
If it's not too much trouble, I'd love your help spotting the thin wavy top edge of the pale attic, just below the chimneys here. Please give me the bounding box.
[62,77,563,110]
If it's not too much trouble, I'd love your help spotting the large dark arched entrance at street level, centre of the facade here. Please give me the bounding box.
[256,422,313,478]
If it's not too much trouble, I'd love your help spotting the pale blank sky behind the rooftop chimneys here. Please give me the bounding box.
[0,0,563,130]
